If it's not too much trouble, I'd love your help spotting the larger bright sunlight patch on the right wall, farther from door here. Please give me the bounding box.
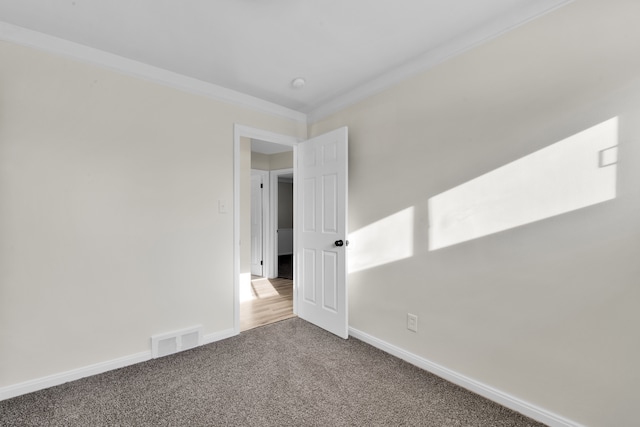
[429,117,618,250]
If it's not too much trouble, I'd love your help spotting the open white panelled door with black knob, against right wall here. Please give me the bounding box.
[295,127,349,338]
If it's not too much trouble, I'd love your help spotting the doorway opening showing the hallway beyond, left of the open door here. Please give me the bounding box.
[236,130,297,333]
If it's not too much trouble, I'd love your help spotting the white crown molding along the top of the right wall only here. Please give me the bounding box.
[303,0,575,124]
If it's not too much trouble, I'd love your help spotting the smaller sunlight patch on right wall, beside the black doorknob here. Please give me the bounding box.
[349,207,414,273]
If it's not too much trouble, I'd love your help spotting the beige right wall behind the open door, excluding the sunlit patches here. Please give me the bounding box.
[310,0,640,426]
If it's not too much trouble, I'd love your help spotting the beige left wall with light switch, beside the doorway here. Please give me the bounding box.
[0,42,306,387]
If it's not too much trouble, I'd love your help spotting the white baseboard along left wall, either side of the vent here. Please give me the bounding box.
[0,329,237,401]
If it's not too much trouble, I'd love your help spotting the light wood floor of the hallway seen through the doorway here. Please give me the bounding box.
[240,276,295,331]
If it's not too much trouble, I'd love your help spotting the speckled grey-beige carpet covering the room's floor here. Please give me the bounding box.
[0,318,542,427]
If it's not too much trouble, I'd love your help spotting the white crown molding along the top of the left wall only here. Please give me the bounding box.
[0,21,307,124]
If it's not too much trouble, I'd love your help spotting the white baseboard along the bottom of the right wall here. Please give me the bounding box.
[349,327,583,427]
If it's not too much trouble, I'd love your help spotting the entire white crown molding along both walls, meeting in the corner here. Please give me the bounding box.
[0,0,574,124]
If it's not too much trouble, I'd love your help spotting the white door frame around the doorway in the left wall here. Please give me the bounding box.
[233,124,304,335]
